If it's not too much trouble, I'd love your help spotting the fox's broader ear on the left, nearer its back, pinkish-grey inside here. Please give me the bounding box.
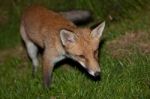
[60,29,76,45]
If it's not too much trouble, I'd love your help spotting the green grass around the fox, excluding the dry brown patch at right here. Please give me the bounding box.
[0,0,150,99]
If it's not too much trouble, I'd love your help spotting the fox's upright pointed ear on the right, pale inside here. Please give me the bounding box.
[91,21,105,39]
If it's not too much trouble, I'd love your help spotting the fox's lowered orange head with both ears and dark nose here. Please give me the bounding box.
[60,22,105,77]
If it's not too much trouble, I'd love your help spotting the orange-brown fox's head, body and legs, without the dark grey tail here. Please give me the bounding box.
[20,6,105,87]
